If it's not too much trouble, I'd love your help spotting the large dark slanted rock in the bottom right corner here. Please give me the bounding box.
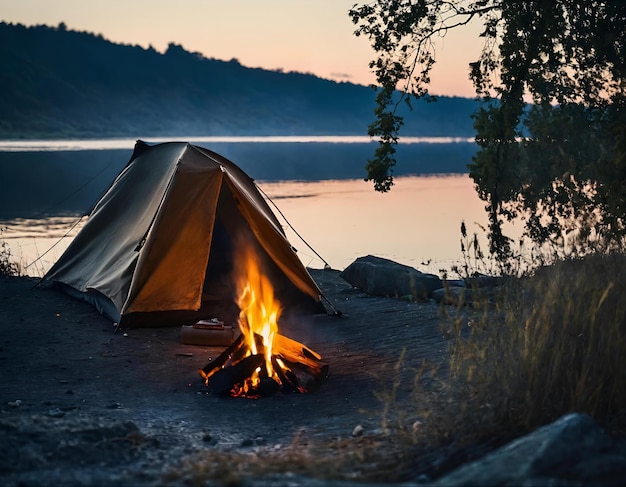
[432,414,626,487]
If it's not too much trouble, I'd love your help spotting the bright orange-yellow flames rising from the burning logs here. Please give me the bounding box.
[233,248,282,395]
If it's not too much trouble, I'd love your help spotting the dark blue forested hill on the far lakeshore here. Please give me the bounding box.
[0,22,476,139]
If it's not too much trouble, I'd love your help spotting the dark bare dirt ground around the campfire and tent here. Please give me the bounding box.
[0,270,447,486]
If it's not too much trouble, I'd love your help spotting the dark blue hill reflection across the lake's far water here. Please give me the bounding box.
[0,138,476,218]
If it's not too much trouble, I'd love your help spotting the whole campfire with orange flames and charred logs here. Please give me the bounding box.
[199,249,328,398]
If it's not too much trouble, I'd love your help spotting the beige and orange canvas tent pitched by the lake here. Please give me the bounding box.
[44,141,325,327]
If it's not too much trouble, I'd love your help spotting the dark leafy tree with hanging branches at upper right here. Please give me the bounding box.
[349,0,626,259]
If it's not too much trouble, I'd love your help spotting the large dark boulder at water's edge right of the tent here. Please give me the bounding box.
[339,255,442,300]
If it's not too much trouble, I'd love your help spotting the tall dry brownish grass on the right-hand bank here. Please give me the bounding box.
[438,254,626,433]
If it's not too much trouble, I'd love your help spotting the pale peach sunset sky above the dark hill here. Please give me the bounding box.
[0,0,481,97]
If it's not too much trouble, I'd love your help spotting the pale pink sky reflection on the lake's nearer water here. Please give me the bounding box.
[0,174,516,276]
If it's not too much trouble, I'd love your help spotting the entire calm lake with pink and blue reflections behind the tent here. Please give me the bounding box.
[0,137,516,276]
